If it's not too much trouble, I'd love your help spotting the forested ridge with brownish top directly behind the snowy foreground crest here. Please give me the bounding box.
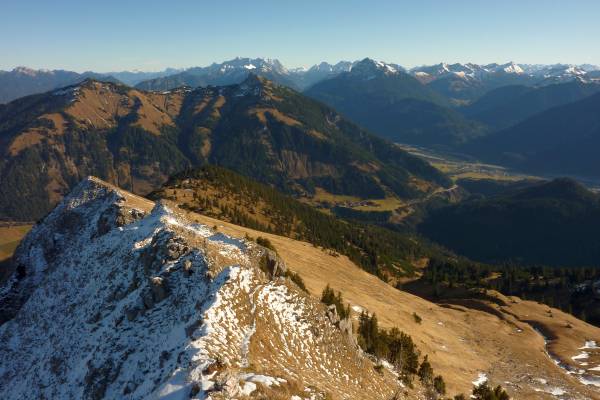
[149,165,443,278]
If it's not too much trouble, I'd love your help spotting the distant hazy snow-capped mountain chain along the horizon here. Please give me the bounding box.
[0,57,600,103]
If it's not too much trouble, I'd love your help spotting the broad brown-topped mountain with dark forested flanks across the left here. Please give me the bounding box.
[0,75,449,220]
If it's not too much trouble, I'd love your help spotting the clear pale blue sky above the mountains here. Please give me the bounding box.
[0,0,600,72]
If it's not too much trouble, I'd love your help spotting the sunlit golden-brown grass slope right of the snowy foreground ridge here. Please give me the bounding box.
[180,211,600,399]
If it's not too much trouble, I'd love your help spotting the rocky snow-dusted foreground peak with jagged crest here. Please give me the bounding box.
[0,178,398,399]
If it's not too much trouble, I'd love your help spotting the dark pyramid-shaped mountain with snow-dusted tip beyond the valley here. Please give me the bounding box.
[305,59,486,145]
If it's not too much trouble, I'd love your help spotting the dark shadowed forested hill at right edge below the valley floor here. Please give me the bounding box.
[421,179,600,266]
